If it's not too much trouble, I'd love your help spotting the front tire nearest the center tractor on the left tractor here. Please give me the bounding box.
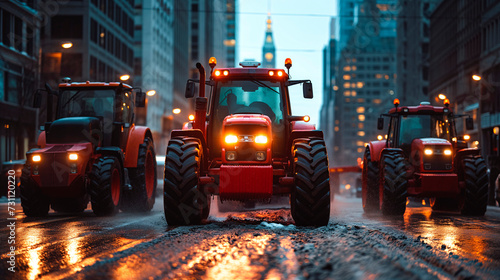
[89,156,123,216]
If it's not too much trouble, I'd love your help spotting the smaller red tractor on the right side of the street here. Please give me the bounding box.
[362,99,488,215]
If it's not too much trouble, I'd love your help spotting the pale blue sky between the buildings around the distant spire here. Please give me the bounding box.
[238,0,337,125]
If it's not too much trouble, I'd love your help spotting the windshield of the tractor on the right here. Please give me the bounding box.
[399,115,453,145]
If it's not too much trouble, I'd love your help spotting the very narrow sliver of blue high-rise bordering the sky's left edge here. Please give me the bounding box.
[224,0,238,67]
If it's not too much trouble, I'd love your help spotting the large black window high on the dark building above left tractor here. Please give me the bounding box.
[50,15,83,39]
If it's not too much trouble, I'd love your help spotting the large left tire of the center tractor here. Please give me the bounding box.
[163,137,210,226]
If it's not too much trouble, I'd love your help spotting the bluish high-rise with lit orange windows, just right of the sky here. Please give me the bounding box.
[333,0,397,165]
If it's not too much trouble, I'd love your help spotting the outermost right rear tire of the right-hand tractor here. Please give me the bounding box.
[461,157,489,216]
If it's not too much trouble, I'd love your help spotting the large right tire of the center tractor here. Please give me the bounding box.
[290,138,330,226]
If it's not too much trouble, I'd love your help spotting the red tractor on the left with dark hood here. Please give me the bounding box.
[20,80,156,217]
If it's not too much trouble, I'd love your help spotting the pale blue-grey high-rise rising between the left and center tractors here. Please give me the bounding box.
[134,0,175,151]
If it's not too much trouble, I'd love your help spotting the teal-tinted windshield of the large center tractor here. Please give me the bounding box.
[214,80,283,124]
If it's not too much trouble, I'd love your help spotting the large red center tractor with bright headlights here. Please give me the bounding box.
[164,58,330,226]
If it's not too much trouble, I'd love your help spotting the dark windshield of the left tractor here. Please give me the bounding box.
[58,89,115,121]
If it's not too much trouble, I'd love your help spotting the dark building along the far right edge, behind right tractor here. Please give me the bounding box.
[429,0,500,205]
